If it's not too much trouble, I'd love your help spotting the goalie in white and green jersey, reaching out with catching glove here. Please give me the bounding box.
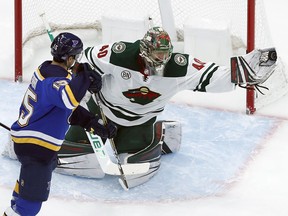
[3,27,277,188]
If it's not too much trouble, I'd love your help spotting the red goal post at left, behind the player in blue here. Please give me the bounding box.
[14,0,22,82]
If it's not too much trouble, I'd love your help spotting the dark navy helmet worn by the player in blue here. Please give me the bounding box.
[51,32,83,61]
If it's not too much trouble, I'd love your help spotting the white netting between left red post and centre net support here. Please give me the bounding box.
[23,0,161,43]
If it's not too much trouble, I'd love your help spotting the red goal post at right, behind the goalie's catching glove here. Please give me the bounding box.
[246,0,256,114]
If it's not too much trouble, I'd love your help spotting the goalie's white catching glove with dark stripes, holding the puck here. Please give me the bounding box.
[231,48,277,85]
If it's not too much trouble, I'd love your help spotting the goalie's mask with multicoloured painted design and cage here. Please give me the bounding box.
[140,27,173,76]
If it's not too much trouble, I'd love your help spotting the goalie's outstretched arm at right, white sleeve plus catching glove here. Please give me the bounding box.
[187,48,277,93]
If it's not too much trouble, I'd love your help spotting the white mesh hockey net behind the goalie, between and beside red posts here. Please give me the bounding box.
[15,0,287,112]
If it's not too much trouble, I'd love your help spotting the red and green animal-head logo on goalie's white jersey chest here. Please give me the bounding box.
[123,86,161,105]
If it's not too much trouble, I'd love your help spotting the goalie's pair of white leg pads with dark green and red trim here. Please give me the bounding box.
[55,121,182,188]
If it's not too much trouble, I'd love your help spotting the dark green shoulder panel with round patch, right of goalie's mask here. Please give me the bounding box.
[164,53,189,77]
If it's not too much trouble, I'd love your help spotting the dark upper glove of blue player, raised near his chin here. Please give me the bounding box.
[77,63,102,93]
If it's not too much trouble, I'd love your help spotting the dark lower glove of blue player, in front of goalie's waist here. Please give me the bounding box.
[85,117,117,139]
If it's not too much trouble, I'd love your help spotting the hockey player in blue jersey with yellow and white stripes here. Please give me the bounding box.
[4,32,116,216]
